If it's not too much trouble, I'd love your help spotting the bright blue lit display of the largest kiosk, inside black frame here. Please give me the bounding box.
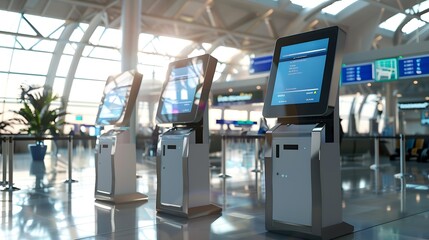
[271,38,329,106]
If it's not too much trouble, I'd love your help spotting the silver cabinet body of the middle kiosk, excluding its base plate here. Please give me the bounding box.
[158,122,210,212]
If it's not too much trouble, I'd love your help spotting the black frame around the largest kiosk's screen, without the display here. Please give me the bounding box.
[263,27,341,118]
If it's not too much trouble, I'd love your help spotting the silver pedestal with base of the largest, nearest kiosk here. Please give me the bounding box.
[265,104,353,239]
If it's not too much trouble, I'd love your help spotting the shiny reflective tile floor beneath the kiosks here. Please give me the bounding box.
[0,143,429,240]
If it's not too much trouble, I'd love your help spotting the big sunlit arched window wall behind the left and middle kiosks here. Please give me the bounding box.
[0,11,248,131]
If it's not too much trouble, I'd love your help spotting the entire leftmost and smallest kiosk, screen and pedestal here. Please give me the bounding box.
[95,71,147,203]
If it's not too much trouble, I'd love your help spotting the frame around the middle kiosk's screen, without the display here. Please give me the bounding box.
[156,54,217,124]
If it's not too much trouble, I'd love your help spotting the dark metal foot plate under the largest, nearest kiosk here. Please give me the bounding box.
[267,222,354,240]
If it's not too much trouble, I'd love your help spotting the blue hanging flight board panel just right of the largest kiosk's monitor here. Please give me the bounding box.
[341,63,374,85]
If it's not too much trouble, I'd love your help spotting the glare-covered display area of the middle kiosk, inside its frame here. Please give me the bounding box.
[161,63,203,114]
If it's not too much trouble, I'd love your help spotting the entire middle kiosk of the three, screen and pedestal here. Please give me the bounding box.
[156,54,221,218]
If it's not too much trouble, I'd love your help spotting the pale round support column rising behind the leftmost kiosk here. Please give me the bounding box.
[121,0,141,143]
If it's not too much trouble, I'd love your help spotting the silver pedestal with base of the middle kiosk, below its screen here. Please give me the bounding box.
[156,109,222,218]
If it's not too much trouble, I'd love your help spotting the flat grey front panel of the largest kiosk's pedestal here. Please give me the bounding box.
[272,129,312,226]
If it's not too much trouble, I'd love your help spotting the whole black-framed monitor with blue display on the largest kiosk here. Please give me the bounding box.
[262,27,345,119]
